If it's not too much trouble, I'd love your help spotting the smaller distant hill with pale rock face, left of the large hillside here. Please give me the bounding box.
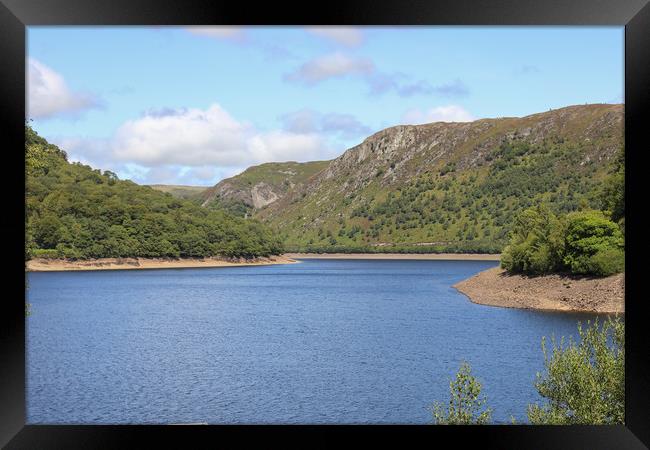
[201,161,329,216]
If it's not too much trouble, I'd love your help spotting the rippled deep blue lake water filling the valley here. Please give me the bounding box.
[26,259,595,424]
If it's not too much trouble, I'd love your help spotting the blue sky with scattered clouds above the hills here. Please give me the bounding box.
[27,27,624,185]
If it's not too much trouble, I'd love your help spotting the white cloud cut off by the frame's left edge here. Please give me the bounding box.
[27,58,100,119]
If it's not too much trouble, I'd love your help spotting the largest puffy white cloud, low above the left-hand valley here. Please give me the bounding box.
[53,104,333,183]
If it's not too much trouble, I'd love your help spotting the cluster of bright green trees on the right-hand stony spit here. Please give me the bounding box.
[501,148,625,276]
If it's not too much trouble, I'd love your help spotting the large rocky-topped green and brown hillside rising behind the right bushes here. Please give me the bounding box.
[251,104,623,252]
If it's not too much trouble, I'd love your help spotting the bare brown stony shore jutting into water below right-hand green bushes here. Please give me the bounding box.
[454,267,625,313]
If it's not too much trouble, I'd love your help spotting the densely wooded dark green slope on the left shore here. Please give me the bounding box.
[25,126,283,259]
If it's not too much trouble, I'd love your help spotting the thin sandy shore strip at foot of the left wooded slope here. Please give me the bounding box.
[26,255,298,272]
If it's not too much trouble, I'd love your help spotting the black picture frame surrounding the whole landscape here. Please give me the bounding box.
[0,0,650,449]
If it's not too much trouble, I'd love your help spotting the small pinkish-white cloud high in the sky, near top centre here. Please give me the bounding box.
[285,52,375,84]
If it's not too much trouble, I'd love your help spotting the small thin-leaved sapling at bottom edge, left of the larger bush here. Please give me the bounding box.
[432,362,492,425]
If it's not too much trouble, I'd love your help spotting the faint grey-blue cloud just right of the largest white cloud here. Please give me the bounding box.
[280,109,372,139]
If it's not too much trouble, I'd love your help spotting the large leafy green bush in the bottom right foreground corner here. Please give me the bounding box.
[528,318,625,425]
